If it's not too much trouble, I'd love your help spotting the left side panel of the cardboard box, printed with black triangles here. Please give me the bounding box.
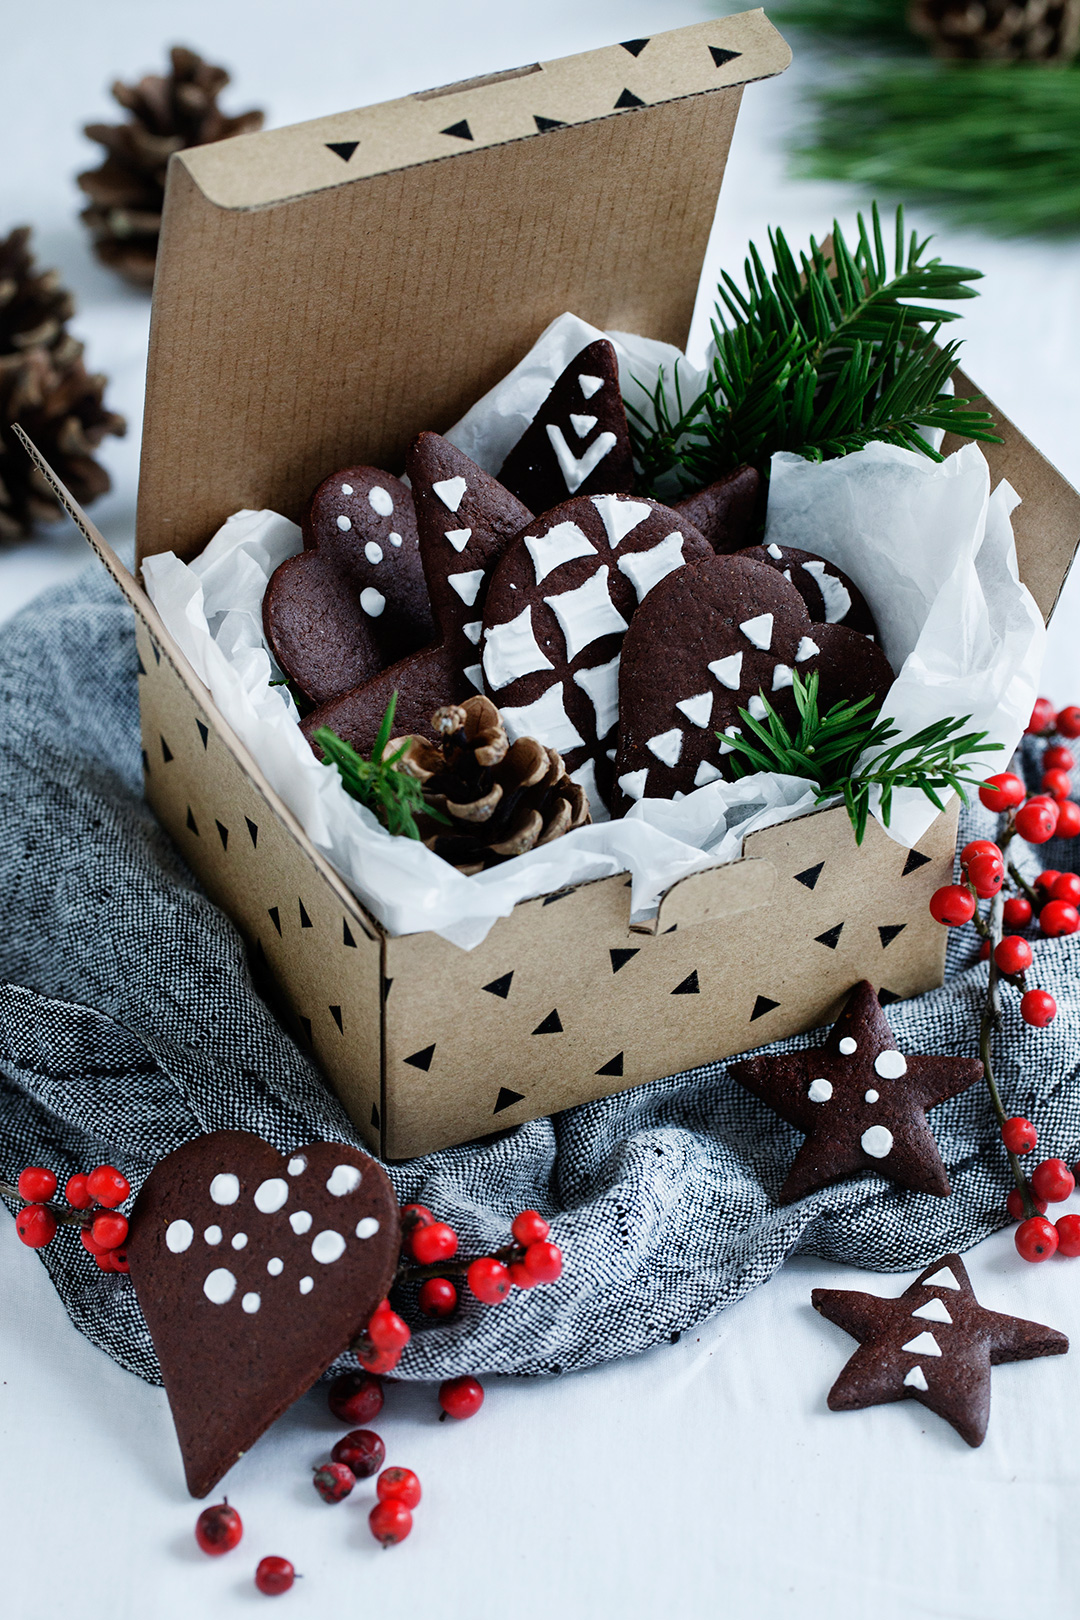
[136,619,382,1152]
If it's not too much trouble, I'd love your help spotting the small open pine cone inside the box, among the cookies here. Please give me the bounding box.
[387,697,591,876]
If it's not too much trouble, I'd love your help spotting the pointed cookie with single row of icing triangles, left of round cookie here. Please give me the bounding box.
[303,433,531,753]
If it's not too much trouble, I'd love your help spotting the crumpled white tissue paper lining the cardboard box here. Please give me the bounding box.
[142,314,1044,949]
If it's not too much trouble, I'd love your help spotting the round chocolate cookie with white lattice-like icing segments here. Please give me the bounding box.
[483,494,712,807]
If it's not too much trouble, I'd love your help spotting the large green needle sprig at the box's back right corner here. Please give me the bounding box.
[627,204,1001,501]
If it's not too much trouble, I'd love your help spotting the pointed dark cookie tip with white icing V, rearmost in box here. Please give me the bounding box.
[499,337,633,512]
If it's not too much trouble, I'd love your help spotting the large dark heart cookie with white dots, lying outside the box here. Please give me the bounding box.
[128,1131,400,1497]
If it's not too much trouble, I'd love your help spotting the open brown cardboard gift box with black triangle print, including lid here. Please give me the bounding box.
[23,11,1080,1158]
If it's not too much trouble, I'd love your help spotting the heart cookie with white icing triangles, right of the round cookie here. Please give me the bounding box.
[615,552,894,812]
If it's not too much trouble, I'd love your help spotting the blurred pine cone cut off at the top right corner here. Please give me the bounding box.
[908,0,1080,62]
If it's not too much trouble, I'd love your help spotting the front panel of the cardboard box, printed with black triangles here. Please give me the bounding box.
[385,807,957,1158]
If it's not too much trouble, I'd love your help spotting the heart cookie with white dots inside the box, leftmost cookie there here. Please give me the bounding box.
[262,467,434,703]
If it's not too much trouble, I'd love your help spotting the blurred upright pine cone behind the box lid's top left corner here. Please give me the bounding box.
[79,45,262,287]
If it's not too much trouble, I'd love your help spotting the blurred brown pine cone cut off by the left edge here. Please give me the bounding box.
[0,225,126,543]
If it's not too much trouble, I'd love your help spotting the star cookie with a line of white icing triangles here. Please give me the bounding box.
[810,1254,1069,1445]
